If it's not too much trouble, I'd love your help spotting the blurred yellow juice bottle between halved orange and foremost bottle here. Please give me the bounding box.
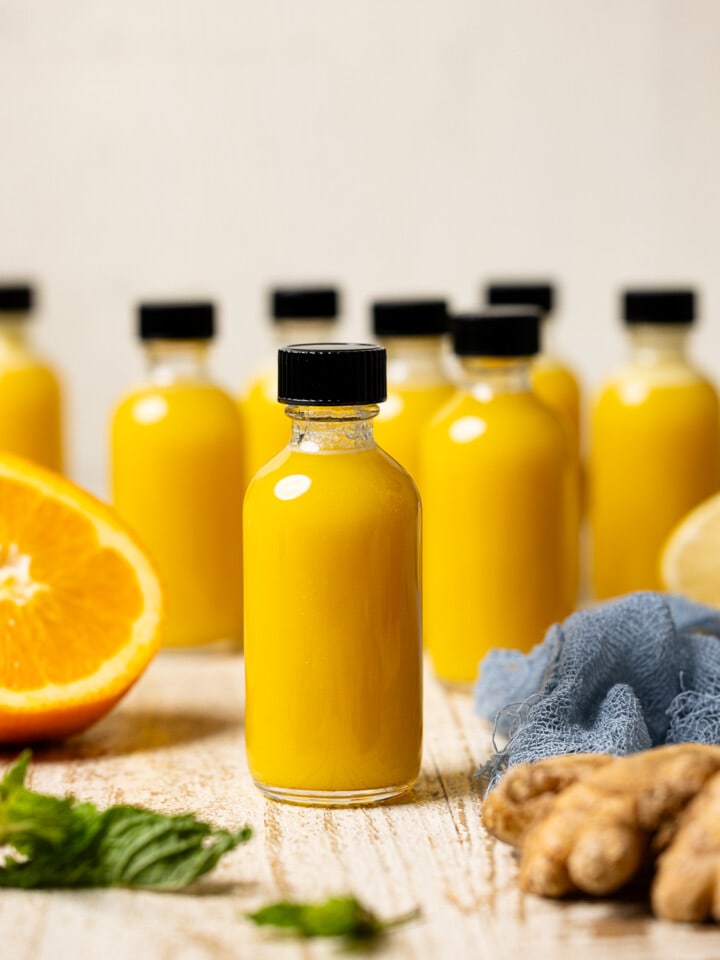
[112,302,243,646]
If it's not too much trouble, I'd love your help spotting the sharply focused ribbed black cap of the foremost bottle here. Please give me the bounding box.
[278,343,387,407]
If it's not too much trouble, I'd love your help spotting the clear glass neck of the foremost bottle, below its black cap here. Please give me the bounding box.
[285,403,379,453]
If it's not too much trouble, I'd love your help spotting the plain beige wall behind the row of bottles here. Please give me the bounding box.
[0,0,720,491]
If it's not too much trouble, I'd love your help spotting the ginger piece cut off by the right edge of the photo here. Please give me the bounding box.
[651,773,720,922]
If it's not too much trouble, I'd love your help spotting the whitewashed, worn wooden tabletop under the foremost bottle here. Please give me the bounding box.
[0,653,720,960]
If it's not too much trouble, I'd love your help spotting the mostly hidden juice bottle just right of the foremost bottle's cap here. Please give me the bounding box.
[372,300,454,486]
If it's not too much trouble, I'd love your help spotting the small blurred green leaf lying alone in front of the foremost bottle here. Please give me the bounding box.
[247,896,419,946]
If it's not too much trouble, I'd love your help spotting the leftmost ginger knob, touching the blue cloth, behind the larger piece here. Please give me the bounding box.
[482,753,613,847]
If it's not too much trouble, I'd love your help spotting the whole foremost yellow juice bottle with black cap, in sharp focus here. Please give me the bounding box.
[244,344,422,805]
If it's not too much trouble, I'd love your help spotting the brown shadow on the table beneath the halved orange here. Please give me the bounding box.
[0,709,242,761]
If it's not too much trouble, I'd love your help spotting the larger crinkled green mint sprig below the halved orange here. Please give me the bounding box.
[0,751,252,890]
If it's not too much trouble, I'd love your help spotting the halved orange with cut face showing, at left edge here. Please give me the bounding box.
[0,454,163,743]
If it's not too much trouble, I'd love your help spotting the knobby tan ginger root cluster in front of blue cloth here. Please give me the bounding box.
[483,744,720,919]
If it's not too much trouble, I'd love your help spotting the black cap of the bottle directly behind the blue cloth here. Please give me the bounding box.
[451,306,542,357]
